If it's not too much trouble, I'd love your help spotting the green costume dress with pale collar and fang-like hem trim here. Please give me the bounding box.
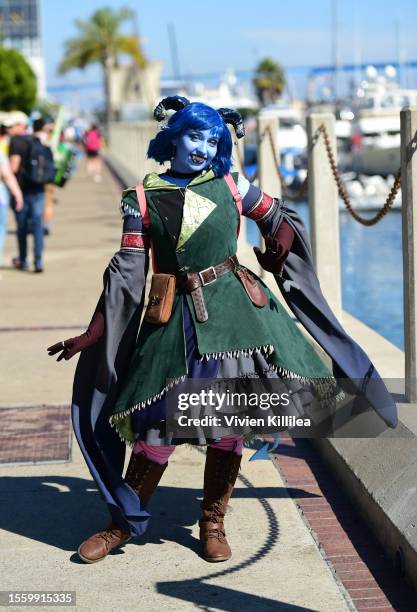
[110,170,332,444]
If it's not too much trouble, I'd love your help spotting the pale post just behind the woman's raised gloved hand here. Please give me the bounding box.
[258,117,281,198]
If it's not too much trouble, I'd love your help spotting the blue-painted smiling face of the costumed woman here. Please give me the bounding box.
[171,128,219,173]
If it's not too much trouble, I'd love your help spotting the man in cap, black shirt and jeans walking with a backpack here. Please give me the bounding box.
[9,113,55,273]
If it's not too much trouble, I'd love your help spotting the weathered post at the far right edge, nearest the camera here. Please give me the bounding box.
[400,108,417,402]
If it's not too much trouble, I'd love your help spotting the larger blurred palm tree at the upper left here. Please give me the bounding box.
[58,7,146,129]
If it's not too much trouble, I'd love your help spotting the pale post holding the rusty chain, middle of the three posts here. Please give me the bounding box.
[307,113,342,317]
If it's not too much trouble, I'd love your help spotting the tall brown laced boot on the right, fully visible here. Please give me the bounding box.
[198,446,242,562]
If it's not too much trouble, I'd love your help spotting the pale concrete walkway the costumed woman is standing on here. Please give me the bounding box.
[0,167,351,612]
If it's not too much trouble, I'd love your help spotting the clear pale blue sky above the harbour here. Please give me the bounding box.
[41,0,417,104]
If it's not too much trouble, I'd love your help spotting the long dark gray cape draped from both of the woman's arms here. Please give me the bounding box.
[72,206,397,535]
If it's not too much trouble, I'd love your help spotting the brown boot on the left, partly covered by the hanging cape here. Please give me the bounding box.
[77,451,168,563]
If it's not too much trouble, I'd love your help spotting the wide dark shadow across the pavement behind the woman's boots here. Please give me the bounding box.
[0,475,318,551]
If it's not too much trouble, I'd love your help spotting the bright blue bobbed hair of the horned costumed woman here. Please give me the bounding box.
[148,102,232,176]
